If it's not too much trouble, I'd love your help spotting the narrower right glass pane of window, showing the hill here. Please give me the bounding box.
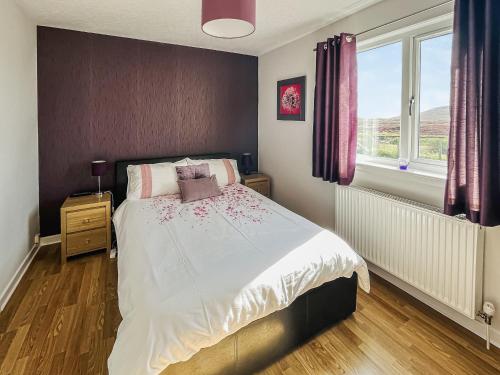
[418,34,452,160]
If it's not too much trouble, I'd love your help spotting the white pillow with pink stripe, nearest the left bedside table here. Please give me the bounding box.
[127,159,188,200]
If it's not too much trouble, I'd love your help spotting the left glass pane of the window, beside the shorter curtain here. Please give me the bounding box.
[358,42,402,159]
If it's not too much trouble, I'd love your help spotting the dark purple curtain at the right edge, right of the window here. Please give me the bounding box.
[444,0,500,226]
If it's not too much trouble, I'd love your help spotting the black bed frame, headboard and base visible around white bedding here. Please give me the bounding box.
[115,153,358,375]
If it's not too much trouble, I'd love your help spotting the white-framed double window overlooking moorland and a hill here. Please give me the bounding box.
[357,18,452,174]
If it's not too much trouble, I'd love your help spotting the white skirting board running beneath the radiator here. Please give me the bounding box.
[367,262,500,348]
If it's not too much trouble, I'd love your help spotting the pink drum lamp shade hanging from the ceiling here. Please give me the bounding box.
[201,0,255,39]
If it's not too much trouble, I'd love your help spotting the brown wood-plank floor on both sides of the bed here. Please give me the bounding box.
[0,245,500,375]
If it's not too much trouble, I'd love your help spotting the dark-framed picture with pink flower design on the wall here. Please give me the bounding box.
[276,76,306,121]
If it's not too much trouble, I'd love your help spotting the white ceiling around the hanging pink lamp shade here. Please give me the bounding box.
[16,0,380,56]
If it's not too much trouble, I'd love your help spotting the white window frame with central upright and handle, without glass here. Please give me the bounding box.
[357,14,453,176]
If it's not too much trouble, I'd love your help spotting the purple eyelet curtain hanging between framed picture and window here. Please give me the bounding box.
[313,34,358,185]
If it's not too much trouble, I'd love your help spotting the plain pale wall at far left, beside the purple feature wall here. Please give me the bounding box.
[0,0,38,308]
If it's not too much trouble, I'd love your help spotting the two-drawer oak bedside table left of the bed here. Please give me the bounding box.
[61,193,111,263]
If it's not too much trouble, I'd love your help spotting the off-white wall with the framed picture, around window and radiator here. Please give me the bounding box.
[259,0,500,344]
